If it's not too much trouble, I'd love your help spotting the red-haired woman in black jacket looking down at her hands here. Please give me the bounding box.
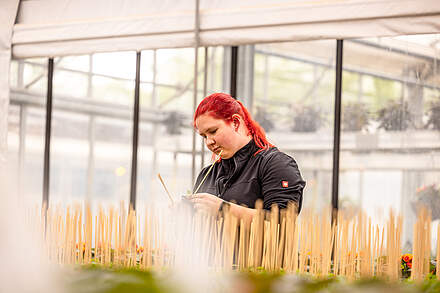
[190,93,305,218]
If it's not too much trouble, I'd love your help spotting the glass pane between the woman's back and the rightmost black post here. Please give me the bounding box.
[252,41,336,209]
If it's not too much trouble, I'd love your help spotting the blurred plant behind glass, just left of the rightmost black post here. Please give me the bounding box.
[291,105,324,132]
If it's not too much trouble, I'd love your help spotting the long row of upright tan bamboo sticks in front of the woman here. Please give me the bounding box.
[29,202,440,280]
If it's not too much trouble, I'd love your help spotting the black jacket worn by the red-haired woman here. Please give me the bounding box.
[195,140,305,212]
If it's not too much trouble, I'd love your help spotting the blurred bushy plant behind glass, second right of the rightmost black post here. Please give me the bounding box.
[377,101,413,131]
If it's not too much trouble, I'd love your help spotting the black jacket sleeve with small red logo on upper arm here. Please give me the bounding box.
[260,151,306,213]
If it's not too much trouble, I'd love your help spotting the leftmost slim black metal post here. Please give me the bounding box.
[43,58,53,210]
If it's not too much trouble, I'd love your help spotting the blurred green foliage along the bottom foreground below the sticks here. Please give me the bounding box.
[63,264,440,293]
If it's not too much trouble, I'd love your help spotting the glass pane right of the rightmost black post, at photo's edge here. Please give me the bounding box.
[340,34,440,249]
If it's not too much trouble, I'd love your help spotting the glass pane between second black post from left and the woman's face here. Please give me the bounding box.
[138,49,199,205]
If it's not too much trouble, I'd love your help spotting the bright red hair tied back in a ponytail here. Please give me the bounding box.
[193,93,273,155]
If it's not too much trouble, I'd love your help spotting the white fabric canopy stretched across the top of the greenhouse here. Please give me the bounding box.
[12,0,440,58]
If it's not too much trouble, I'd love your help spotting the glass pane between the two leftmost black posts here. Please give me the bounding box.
[50,52,136,209]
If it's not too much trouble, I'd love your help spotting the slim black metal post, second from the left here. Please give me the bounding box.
[130,52,141,210]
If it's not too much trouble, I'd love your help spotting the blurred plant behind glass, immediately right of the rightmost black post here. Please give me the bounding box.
[341,102,370,131]
